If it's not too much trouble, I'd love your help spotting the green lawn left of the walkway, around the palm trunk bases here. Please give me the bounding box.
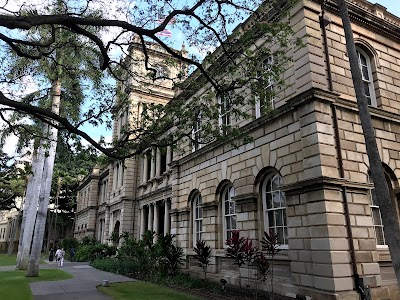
[0,269,73,300]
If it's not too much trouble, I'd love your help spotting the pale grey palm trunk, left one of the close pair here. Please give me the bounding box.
[16,140,45,270]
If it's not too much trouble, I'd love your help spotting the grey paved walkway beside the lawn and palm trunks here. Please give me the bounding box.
[0,261,134,300]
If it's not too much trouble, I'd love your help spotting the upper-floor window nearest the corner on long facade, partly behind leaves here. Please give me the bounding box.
[256,56,274,118]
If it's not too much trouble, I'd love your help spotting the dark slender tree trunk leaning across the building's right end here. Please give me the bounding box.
[338,0,400,286]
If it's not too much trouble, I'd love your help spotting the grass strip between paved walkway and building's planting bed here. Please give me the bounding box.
[98,281,201,300]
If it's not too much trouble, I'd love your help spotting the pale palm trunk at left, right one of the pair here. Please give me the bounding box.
[26,79,61,277]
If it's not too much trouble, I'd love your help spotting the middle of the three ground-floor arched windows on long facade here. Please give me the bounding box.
[222,186,236,242]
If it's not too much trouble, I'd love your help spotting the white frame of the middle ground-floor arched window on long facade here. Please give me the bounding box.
[221,185,237,247]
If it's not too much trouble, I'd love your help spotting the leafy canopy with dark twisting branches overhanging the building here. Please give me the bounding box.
[0,0,297,158]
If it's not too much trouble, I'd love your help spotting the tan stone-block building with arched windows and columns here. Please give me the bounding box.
[75,0,400,299]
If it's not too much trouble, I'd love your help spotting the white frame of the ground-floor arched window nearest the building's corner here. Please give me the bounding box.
[261,172,289,249]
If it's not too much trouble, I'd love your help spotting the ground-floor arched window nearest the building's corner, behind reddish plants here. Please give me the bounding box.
[262,173,288,245]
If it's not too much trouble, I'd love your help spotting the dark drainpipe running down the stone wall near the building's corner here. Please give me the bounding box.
[319,1,366,300]
